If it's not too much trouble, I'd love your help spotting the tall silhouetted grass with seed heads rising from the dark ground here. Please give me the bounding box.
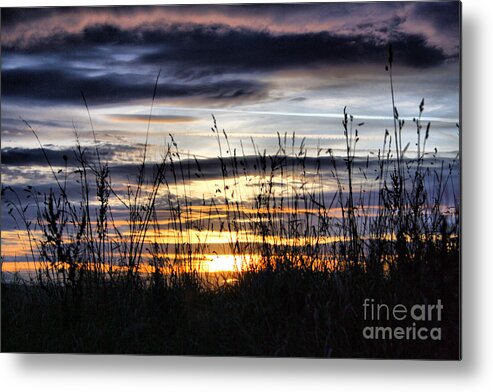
[2,51,460,359]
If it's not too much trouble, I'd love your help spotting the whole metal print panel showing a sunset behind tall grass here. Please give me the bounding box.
[1,1,461,360]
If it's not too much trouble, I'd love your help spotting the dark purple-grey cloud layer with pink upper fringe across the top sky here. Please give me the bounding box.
[2,2,459,105]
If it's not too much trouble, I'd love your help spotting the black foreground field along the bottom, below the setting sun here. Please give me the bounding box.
[2,248,460,359]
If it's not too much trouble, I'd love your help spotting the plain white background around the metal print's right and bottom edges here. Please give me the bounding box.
[0,0,493,392]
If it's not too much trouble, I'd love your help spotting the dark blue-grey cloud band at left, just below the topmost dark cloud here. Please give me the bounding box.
[2,65,267,105]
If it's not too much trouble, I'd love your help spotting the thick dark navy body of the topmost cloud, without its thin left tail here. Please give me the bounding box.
[140,26,446,71]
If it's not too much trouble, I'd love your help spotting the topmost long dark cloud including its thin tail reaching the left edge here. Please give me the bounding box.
[3,18,447,72]
